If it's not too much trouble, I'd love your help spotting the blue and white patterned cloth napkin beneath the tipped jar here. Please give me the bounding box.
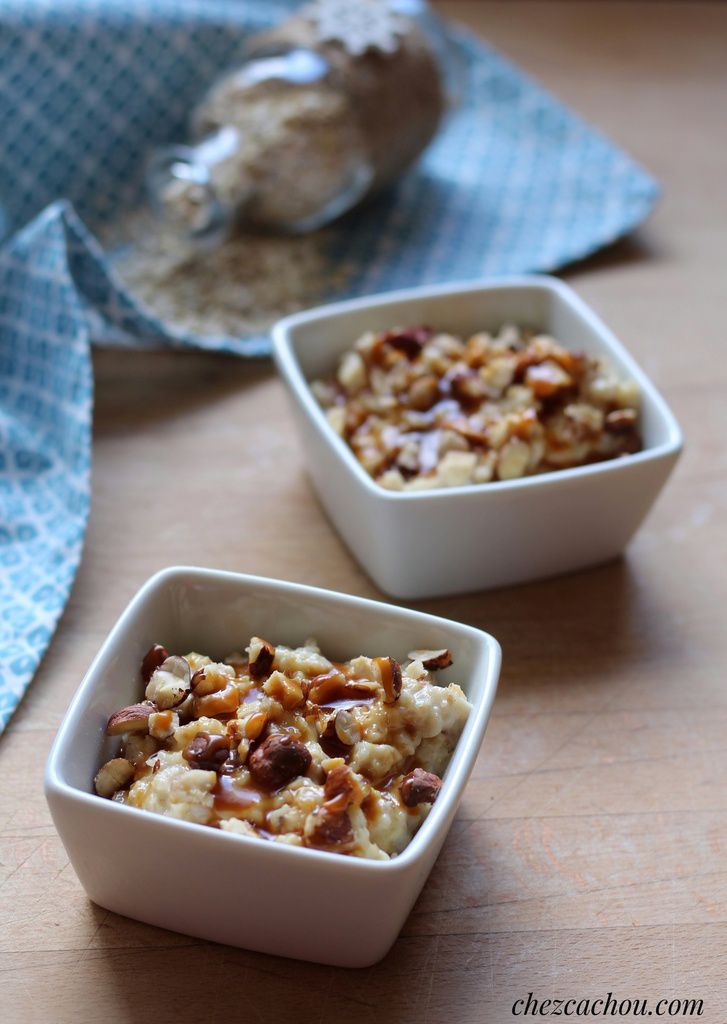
[0,0,657,729]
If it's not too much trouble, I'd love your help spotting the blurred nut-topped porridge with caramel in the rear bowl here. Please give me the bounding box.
[311,325,642,490]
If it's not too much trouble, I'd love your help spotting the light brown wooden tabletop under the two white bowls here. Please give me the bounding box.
[0,2,727,1024]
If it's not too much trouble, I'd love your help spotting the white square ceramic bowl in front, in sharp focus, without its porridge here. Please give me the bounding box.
[45,567,500,967]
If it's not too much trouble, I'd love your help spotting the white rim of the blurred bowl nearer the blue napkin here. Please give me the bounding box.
[271,274,684,502]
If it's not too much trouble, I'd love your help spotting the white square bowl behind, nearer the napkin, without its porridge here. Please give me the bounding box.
[272,276,682,599]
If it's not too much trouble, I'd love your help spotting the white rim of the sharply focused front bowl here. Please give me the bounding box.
[44,565,502,873]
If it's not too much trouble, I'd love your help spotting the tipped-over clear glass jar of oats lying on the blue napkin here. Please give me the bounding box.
[147,0,444,244]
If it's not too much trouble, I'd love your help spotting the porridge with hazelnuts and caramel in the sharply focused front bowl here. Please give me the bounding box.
[95,637,471,859]
